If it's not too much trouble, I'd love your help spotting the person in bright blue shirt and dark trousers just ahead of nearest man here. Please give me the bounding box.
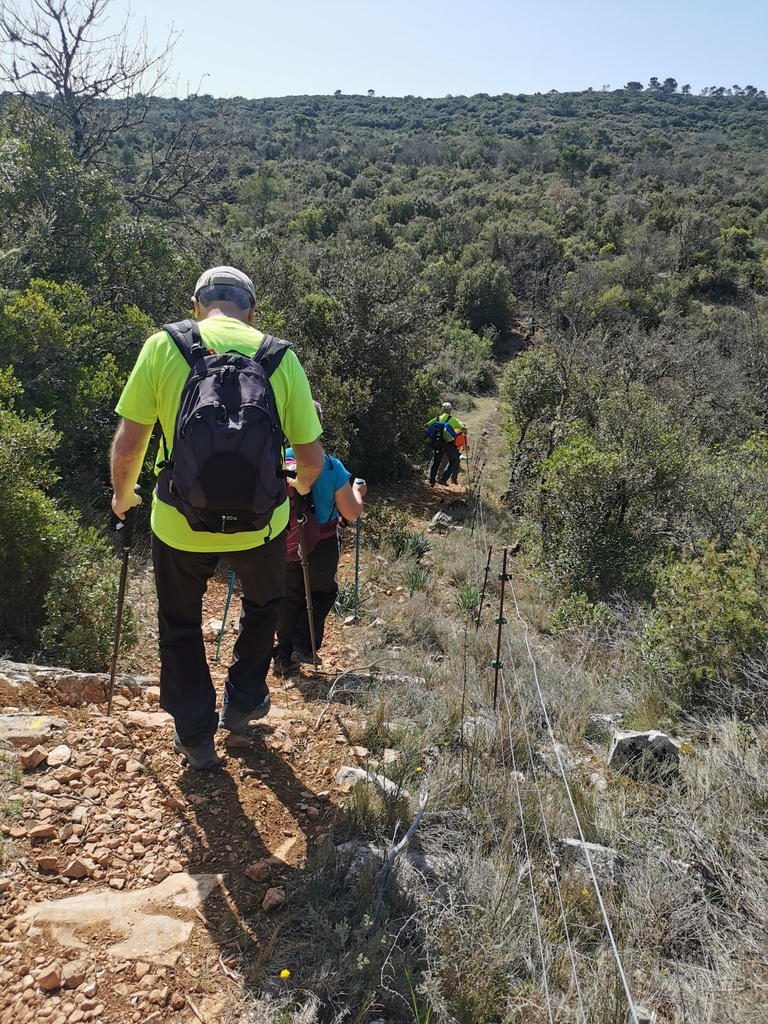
[273,401,368,677]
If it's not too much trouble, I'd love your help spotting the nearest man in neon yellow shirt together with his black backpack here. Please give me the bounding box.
[112,266,323,770]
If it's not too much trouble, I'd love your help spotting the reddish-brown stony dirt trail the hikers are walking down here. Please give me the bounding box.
[0,399,505,1024]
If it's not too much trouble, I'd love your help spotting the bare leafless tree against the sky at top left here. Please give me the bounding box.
[0,0,177,164]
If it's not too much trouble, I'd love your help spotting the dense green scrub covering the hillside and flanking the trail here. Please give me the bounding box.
[0,79,768,707]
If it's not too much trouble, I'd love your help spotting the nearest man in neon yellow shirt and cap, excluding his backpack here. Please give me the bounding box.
[112,266,323,770]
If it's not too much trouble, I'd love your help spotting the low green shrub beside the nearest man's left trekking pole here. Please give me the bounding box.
[40,529,136,672]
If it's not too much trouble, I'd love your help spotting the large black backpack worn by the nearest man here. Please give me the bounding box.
[158,319,289,534]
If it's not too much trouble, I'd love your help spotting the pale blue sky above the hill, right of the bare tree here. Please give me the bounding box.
[113,0,768,98]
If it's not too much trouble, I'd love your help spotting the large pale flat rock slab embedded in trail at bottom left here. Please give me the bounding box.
[18,872,221,967]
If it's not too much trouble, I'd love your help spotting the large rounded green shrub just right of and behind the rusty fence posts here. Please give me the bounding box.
[537,387,691,600]
